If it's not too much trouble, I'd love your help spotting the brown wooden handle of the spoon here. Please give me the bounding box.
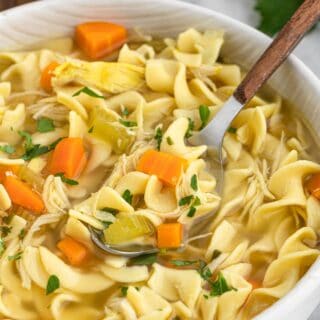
[234,0,320,104]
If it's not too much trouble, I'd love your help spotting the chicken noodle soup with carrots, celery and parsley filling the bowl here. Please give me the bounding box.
[0,22,320,320]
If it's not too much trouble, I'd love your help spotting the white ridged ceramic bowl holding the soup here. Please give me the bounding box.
[0,0,320,320]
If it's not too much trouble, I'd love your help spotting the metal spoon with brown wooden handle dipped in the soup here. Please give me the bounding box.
[90,0,320,257]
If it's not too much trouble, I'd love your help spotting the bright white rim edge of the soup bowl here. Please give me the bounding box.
[0,0,320,320]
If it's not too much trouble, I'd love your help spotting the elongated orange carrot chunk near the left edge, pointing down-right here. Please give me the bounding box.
[3,176,45,214]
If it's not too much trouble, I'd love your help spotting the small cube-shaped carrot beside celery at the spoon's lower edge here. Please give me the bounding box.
[157,223,182,249]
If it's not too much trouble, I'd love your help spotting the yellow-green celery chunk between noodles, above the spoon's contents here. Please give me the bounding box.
[90,108,134,154]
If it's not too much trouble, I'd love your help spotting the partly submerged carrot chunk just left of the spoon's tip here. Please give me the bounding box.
[57,237,90,266]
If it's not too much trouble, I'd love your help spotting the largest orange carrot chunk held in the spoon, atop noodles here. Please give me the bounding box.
[137,150,187,187]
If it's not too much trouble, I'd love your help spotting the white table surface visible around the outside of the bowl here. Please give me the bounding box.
[184,0,320,320]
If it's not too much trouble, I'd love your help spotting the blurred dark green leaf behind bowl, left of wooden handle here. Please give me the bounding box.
[255,0,310,36]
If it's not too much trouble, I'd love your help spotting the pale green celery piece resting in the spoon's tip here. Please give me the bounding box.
[104,215,154,244]
